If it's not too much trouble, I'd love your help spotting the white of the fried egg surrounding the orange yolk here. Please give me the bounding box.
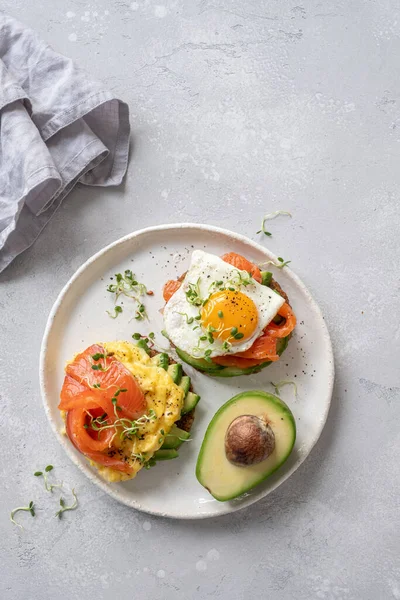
[164,250,285,358]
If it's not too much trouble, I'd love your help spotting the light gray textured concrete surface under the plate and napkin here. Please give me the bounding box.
[0,0,400,600]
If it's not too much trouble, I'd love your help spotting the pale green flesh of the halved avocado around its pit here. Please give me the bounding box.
[196,391,296,502]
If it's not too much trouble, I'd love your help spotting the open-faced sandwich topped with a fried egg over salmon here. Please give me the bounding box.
[163,250,296,377]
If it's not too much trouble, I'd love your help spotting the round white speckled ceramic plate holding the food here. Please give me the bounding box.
[40,224,334,519]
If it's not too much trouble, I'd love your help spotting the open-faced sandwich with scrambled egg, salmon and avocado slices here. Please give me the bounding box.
[58,340,199,481]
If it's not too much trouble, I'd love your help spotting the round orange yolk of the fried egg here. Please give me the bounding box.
[201,290,258,344]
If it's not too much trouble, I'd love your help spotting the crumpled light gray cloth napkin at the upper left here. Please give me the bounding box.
[0,12,130,272]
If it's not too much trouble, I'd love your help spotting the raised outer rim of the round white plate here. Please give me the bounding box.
[39,223,335,520]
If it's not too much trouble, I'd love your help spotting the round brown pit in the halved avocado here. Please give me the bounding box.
[225,415,275,467]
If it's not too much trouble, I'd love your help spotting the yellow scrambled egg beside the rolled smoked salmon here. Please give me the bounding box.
[90,342,184,482]
